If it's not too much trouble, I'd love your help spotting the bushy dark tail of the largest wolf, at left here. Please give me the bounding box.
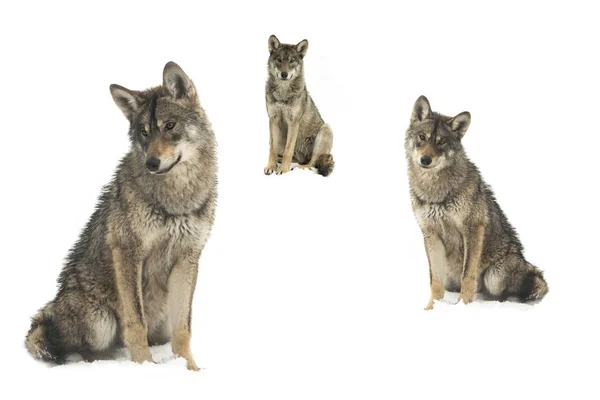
[25,306,65,364]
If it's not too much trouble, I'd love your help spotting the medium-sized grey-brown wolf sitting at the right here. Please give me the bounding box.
[405,96,548,310]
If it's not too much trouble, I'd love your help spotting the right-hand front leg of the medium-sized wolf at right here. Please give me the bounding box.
[458,225,485,304]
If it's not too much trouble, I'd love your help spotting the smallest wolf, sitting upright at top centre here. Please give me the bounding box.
[264,35,334,176]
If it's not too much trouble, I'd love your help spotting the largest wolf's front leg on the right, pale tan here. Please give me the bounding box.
[167,250,200,371]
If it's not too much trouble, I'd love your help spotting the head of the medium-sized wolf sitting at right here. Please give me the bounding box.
[404,96,471,170]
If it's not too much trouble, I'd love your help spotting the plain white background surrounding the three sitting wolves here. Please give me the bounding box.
[0,1,600,399]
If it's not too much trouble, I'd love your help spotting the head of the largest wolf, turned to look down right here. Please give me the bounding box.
[110,62,209,174]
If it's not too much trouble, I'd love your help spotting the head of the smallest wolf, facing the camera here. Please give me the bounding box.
[269,35,308,81]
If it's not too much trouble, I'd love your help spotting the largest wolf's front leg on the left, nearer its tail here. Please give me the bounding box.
[112,247,152,363]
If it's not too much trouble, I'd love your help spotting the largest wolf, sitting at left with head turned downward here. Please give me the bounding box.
[25,62,217,370]
